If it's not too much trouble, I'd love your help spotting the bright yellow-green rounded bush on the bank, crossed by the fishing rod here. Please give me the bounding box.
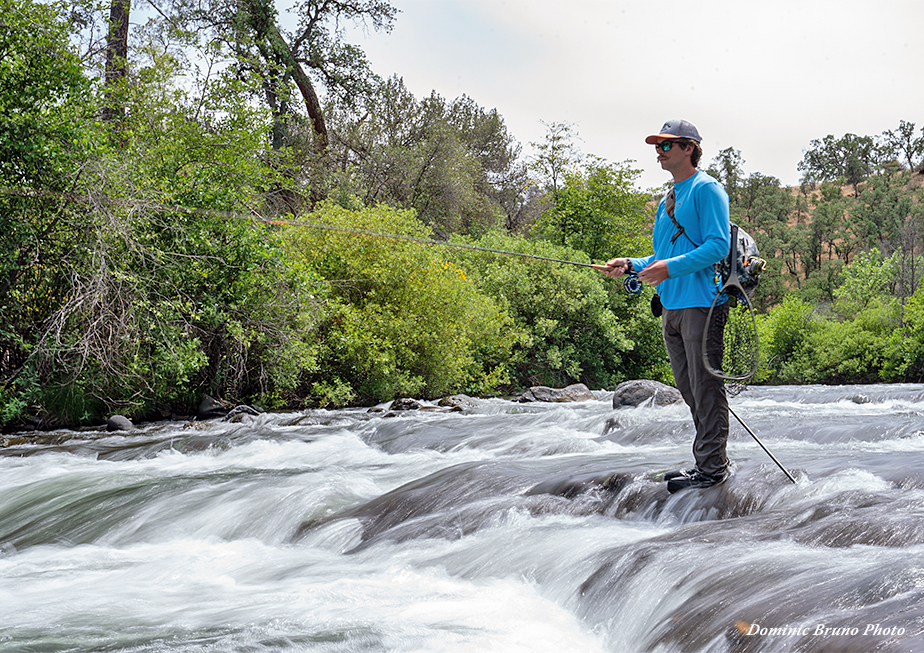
[286,203,516,404]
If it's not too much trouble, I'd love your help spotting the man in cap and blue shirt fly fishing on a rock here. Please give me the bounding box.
[595,120,731,492]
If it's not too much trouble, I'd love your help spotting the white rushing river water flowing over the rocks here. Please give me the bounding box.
[0,385,924,653]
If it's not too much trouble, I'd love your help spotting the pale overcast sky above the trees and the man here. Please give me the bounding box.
[342,0,924,187]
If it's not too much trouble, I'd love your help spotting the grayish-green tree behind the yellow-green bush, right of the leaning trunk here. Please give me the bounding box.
[330,77,526,236]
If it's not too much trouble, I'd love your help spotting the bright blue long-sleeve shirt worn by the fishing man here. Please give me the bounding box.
[629,171,731,309]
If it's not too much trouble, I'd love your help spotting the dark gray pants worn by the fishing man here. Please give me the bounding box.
[661,304,728,476]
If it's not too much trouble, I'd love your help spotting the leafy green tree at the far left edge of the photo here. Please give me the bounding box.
[0,0,95,424]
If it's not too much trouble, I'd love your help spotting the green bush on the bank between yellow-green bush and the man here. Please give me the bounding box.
[452,233,666,388]
